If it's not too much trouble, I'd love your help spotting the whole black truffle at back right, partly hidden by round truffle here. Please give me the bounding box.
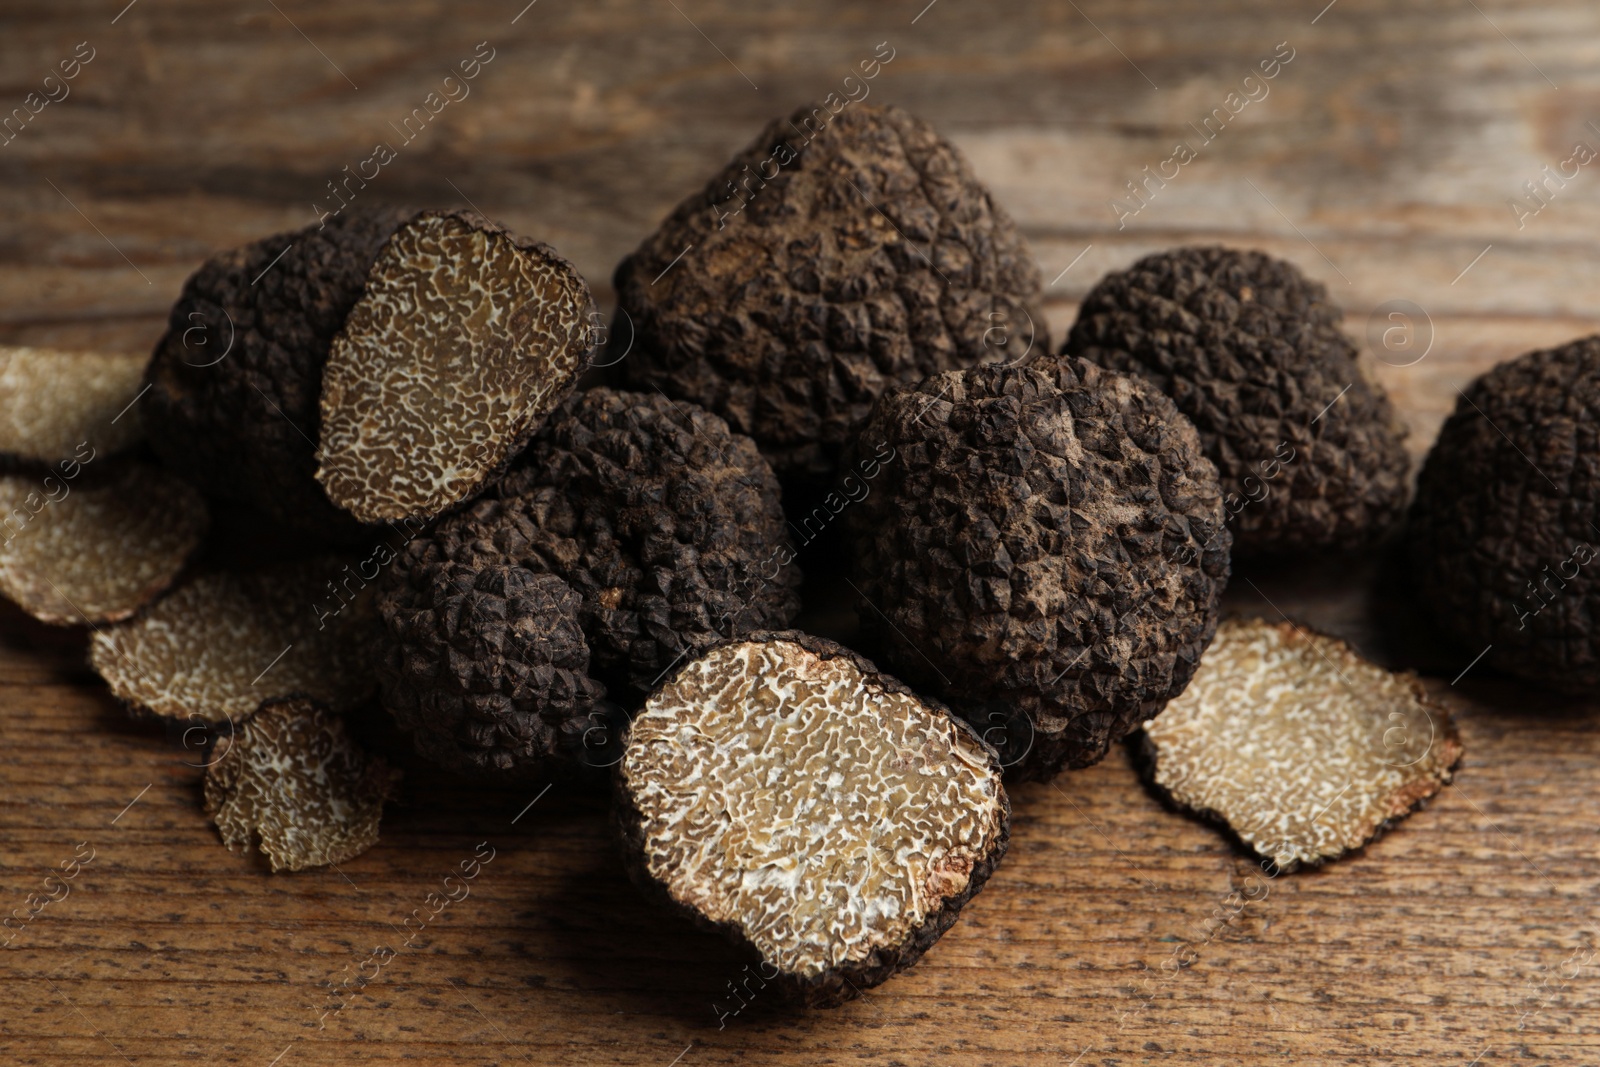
[1064,248,1410,557]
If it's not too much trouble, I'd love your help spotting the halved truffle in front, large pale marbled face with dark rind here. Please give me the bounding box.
[616,632,1010,1005]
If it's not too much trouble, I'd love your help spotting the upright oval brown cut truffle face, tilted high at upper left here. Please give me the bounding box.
[317,211,595,522]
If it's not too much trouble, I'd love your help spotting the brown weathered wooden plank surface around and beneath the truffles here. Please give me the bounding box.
[0,0,1600,1067]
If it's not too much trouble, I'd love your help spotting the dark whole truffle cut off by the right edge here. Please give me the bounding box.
[1408,336,1600,693]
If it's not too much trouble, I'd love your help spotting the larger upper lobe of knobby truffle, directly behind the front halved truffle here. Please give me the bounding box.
[392,389,800,694]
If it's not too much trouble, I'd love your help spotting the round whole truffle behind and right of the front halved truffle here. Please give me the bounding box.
[845,360,1229,779]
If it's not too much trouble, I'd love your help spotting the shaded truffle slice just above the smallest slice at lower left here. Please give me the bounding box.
[90,560,376,723]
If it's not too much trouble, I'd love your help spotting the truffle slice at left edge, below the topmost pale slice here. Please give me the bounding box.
[0,464,208,625]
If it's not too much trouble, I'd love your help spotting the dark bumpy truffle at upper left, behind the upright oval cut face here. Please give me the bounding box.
[141,208,413,541]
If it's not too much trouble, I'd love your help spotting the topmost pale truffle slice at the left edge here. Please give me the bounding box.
[0,346,150,464]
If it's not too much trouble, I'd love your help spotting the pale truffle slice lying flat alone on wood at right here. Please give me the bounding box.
[1144,619,1461,870]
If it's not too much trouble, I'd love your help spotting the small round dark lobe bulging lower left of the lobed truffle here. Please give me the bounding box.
[378,560,605,776]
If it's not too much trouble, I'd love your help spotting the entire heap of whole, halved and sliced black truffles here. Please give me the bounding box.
[43,97,1600,1005]
